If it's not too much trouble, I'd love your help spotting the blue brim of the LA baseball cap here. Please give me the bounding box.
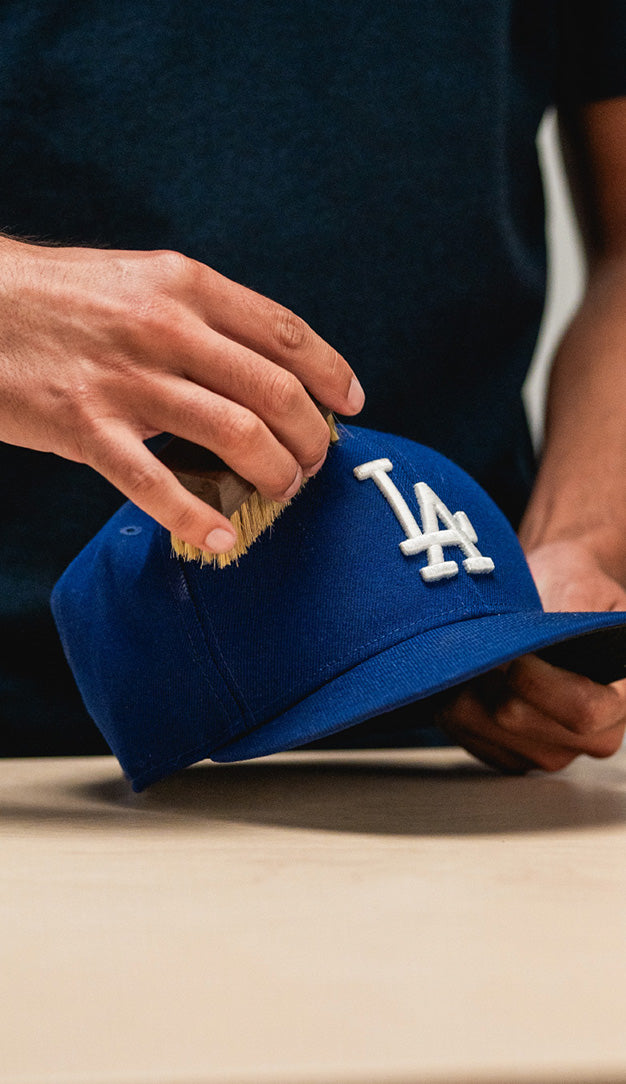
[210,611,626,762]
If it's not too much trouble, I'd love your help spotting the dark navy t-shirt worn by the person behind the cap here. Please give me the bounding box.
[0,0,626,754]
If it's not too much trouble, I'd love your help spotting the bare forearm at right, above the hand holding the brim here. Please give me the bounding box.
[520,250,626,584]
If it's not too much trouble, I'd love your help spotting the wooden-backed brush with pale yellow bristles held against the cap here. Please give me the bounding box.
[158,407,338,568]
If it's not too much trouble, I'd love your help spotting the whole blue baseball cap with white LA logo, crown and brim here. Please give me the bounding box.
[52,426,626,790]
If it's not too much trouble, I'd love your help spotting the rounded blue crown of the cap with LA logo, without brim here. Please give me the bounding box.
[53,427,541,775]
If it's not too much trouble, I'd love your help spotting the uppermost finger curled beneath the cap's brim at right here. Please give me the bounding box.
[507,655,626,734]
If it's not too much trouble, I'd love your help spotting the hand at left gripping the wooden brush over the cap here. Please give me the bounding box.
[0,237,363,553]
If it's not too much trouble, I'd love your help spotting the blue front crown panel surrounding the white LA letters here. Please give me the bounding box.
[178,428,541,721]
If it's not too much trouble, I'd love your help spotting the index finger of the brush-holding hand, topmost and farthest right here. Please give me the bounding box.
[185,263,365,414]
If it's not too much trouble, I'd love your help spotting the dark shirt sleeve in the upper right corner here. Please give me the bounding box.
[559,0,626,104]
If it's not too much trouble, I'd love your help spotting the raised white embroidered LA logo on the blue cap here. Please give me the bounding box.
[354,460,495,583]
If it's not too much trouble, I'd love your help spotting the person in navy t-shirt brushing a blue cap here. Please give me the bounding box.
[0,0,626,771]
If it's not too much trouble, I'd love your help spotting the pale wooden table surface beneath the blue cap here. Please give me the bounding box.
[0,749,626,1084]
